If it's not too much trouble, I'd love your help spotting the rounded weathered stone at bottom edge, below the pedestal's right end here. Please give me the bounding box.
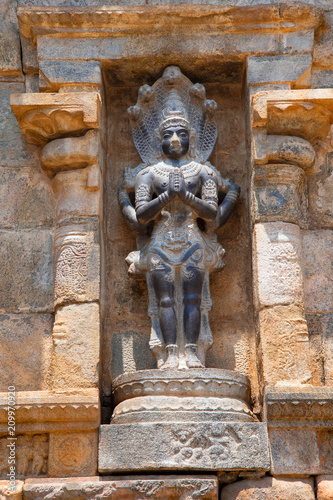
[221,477,315,500]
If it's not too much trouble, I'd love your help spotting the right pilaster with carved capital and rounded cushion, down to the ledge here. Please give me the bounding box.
[251,90,333,385]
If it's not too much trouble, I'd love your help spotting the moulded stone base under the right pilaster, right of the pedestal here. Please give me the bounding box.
[265,386,333,475]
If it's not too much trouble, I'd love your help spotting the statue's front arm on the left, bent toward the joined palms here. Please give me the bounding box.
[135,170,171,225]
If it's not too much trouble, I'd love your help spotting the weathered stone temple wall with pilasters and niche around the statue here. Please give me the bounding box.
[0,0,333,500]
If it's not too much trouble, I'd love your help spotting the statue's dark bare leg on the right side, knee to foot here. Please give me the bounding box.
[182,266,204,368]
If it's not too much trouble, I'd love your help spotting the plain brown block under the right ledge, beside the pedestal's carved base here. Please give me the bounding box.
[268,428,321,475]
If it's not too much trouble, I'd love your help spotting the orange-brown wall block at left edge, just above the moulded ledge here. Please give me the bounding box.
[0,314,53,391]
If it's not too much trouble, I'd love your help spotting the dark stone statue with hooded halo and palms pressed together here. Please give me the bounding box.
[119,66,240,369]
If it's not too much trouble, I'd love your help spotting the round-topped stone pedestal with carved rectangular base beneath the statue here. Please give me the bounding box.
[99,369,270,473]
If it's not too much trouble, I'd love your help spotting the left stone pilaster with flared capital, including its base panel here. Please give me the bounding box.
[11,91,101,477]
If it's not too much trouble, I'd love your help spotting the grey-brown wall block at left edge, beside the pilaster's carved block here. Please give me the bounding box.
[0,229,53,313]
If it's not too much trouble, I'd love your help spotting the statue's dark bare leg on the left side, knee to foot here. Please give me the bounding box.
[151,269,178,369]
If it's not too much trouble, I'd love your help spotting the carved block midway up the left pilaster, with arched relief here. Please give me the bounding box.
[54,218,100,305]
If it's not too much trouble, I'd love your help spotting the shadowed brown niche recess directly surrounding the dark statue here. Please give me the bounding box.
[102,56,256,408]
